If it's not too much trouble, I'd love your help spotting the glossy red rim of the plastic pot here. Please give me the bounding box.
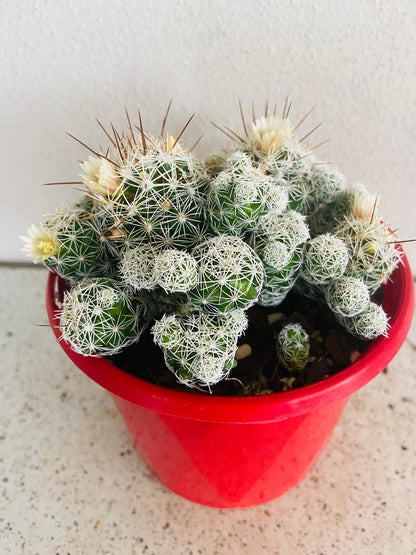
[46,245,415,424]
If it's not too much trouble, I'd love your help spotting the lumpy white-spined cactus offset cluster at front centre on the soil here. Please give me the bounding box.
[152,311,247,387]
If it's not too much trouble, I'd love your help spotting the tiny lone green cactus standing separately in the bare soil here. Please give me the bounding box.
[276,324,309,373]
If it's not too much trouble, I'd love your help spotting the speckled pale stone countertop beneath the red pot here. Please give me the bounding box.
[0,267,416,555]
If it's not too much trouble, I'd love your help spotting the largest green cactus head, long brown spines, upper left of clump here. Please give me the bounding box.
[107,148,207,249]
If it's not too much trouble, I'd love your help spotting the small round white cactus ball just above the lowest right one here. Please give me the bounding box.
[325,276,370,316]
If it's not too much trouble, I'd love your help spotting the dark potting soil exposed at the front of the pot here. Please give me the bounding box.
[108,292,381,396]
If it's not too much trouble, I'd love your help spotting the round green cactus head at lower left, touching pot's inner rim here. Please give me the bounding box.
[60,278,148,356]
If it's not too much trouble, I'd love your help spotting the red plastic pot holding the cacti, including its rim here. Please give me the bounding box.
[46,251,414,507]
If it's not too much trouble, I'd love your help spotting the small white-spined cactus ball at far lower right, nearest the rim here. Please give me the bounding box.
[339,302,389,340]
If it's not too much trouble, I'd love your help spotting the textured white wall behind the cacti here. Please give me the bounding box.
[0,0,416,268]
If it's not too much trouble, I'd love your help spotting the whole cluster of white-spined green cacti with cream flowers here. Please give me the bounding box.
[24,106,400,388]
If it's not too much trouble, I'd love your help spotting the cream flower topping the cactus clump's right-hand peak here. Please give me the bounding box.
[249,116,295,154]
